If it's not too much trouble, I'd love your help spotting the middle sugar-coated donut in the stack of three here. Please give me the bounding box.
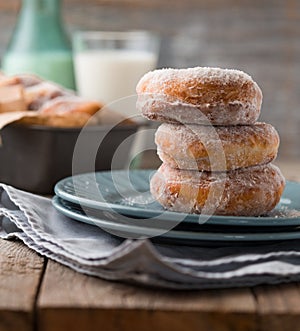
[155,123,279,171]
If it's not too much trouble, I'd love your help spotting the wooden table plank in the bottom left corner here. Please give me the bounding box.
[0,240,44,331]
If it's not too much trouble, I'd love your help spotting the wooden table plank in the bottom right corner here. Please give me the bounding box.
[253,283,300,331]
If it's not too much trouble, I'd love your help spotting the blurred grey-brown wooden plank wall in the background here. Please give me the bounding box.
[0,0,300,158]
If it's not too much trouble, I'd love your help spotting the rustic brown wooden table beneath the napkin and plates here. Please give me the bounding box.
[0,162,300,331]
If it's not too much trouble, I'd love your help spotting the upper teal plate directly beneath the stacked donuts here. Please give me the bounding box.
[55,170,300,227]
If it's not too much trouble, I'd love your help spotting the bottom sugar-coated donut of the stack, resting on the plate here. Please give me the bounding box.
[150,163,285,216]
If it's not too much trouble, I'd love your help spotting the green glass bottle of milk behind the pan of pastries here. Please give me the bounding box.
[2,0,75,89]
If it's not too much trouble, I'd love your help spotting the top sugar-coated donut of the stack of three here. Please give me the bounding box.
[136,67,262,125]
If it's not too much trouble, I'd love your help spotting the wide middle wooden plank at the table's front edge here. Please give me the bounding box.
[37,261,256,331]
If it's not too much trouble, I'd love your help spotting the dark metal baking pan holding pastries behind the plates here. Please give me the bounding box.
[0,124,138,194]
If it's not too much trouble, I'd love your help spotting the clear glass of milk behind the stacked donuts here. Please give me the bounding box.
[73,31,159,116]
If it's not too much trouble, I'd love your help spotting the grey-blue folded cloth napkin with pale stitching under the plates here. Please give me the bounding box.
[0,184,300,289]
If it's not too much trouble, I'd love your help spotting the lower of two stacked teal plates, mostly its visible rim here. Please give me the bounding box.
[52,196,300,244]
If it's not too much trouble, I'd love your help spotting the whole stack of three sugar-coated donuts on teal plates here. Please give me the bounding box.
[137,67,285,216]
